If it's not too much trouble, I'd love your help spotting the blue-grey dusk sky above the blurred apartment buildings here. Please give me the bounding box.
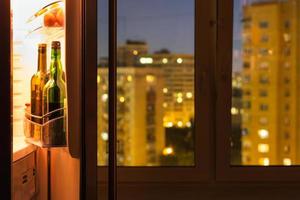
[98,0,249,71]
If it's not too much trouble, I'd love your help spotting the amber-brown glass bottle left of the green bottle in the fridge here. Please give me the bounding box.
[31,44,48,140]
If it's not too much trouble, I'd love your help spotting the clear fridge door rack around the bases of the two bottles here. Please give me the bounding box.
[24,108,67,148]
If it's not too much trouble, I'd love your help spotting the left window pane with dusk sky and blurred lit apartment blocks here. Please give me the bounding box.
[98,0,195,166]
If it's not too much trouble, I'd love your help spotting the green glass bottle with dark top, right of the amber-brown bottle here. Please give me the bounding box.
[43,41,66,146]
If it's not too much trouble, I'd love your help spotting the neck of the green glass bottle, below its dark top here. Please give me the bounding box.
[50,49,63,81]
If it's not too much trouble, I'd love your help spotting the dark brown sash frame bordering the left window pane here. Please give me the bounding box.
[97,0,216,183]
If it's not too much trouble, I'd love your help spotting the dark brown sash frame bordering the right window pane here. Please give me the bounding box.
[216,0,300,182]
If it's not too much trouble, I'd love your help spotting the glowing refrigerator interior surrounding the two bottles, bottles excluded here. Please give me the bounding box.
[10,0,80,200]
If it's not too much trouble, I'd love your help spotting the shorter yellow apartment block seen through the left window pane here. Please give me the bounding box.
[98,67,165,166]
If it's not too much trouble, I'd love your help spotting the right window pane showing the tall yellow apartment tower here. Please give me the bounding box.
[231,0,300,166]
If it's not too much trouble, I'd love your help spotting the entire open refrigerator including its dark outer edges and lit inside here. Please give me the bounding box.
[0,0,96,200]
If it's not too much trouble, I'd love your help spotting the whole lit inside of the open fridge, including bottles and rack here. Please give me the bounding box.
[11,0,80,200]
